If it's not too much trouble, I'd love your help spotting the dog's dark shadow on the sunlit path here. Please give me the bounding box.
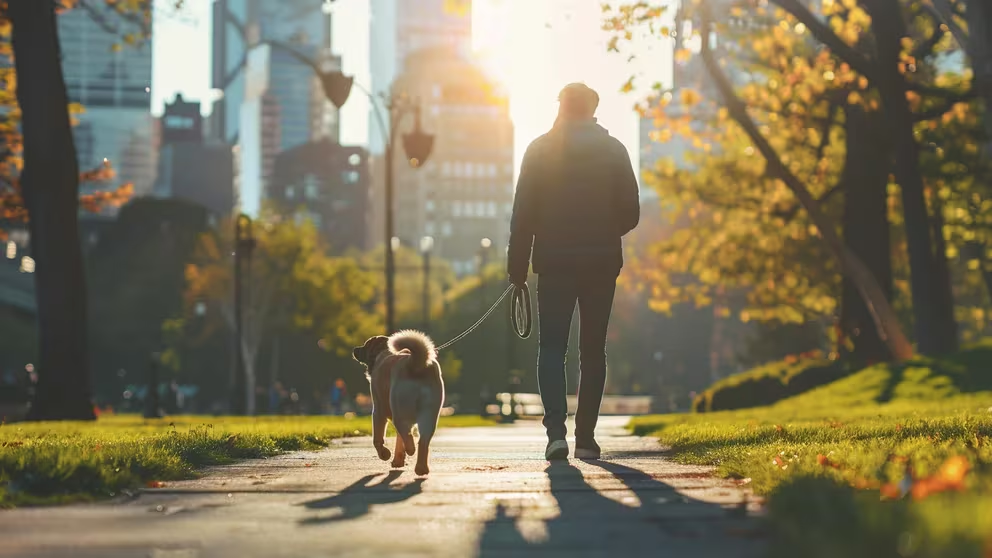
[299,470,424,525]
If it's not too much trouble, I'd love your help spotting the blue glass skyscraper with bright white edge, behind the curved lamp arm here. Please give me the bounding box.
[210,0,339,217]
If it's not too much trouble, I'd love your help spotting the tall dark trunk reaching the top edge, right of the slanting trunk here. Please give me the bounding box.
[865,0,957,355]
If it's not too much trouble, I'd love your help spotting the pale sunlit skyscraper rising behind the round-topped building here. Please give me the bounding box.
[369,0,472,155]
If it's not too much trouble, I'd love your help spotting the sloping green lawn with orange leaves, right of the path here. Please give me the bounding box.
[631,346,992,558]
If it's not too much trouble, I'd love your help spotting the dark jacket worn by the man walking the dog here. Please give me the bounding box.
[507,119,640,283]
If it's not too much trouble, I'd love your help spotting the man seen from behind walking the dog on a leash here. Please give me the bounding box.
[507,83,640,460]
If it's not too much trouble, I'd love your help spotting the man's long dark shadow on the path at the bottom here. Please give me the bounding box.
[478,461,754,558]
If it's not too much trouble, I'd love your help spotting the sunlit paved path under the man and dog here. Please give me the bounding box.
[0,418,762,558]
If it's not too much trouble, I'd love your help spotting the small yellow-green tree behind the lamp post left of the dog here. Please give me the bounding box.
[185,216,381,414]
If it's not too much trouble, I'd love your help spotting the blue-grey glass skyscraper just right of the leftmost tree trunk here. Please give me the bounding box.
[58,7,156,199]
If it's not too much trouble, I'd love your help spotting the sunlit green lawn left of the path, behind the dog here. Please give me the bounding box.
[0,415,492,507]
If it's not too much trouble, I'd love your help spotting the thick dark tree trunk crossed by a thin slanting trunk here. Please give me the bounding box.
[840,106,892,366]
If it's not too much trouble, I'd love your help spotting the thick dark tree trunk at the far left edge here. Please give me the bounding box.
[8,0,94,420]
